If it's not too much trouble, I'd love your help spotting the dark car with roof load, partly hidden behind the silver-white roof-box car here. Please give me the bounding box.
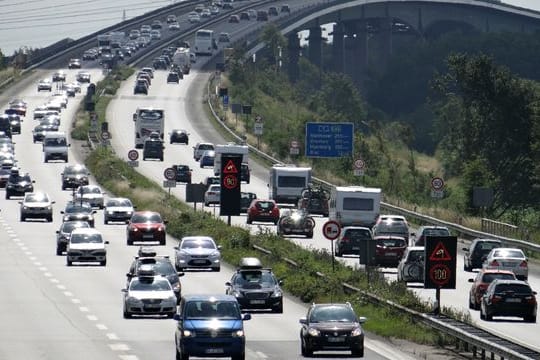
[126,255,184,303]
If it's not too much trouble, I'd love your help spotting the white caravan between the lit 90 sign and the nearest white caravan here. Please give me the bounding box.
[268,165,312,205]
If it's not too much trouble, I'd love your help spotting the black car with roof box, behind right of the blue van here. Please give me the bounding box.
[225,258,283,313]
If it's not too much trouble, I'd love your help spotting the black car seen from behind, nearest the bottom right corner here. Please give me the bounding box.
[480,279,538,323]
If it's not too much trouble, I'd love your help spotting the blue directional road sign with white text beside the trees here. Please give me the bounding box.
[305,123,354,158]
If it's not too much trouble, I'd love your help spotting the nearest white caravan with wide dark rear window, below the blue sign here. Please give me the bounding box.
[328,186,382,228]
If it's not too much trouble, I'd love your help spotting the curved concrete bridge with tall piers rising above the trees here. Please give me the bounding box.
[282,0,540,84]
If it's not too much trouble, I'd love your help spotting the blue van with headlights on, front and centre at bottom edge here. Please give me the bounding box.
[174,294,251,359]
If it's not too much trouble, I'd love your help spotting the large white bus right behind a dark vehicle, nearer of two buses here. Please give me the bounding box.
[133,107,165,149]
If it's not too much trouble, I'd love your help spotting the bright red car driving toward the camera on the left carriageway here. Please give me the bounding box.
[126,211,167,245]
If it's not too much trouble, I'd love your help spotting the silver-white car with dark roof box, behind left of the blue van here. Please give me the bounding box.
[122,266,177,319]
